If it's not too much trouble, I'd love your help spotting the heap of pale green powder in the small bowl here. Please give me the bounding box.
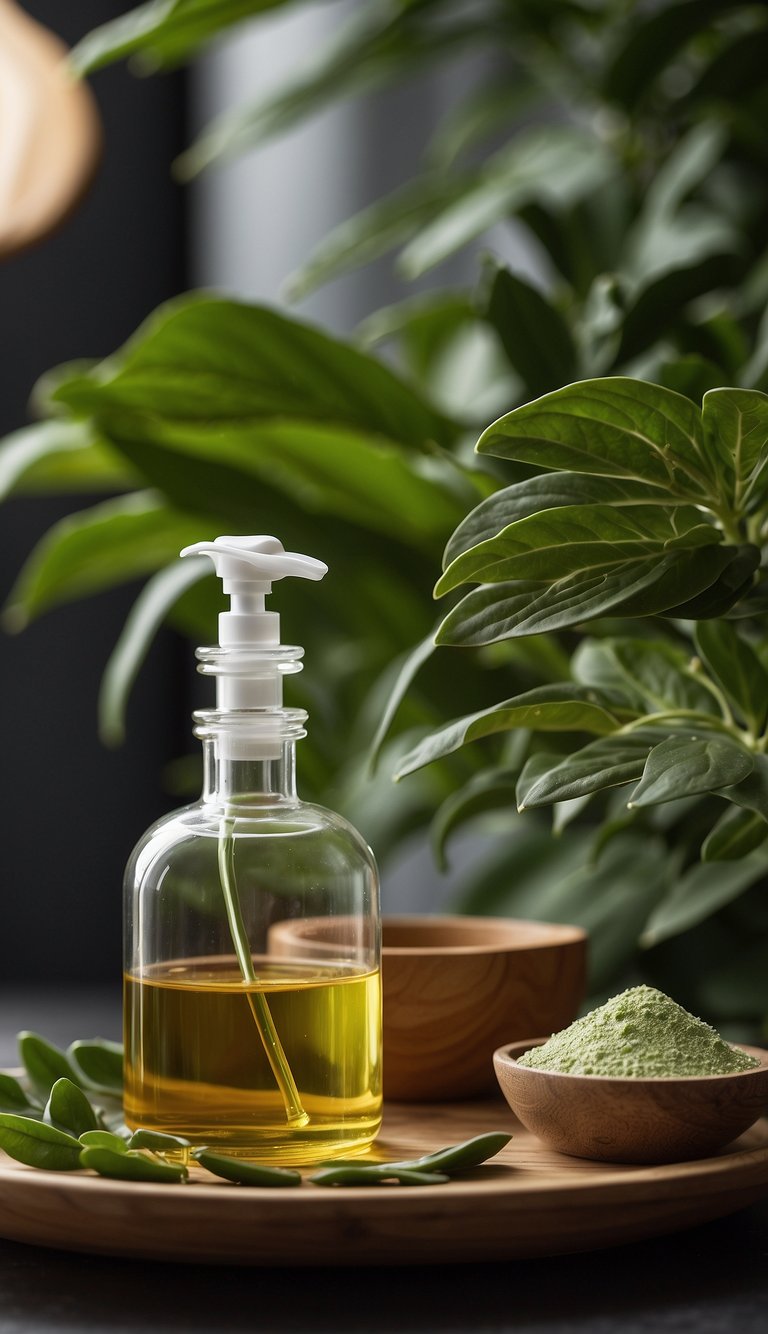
[517,987,760,1078]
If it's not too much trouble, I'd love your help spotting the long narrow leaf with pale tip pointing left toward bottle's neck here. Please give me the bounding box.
[395,682,619,779]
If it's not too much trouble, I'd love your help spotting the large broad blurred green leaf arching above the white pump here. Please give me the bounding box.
[53,293,455,451]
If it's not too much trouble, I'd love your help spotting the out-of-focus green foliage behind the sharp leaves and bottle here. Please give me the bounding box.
[0,0,768,1029]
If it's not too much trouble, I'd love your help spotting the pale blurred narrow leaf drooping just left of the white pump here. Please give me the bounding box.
[99,558,211,746]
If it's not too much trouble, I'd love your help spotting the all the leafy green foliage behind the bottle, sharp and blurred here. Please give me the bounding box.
[0,0,768,1023]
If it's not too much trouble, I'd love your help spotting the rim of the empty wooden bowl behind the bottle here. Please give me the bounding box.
[381,914,587,958]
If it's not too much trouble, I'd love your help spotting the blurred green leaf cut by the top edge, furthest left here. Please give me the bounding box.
[71,0,300,73]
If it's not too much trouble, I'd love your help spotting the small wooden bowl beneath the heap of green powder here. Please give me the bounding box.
[493,1038,768,1163]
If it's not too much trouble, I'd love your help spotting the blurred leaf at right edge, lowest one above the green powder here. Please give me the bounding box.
[641,851,768,947]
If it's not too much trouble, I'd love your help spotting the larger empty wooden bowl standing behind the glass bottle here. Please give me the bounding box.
[381,916,587,1102]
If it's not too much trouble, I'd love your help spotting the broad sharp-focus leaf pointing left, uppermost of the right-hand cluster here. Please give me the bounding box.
[477,376,717,503]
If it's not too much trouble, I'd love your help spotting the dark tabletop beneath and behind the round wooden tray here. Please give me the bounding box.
[0,990,768,1334]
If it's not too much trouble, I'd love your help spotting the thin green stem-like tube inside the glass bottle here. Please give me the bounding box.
[219,815,309,1126]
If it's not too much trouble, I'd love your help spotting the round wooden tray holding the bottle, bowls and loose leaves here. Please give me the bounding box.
[0,1101,768,1266]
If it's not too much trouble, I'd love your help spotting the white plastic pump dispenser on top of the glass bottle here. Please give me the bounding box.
[181,536,328,710]
